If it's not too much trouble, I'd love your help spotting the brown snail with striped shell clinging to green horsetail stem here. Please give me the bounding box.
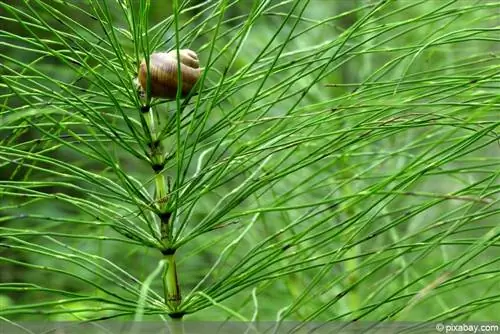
[136,49,201,99]
